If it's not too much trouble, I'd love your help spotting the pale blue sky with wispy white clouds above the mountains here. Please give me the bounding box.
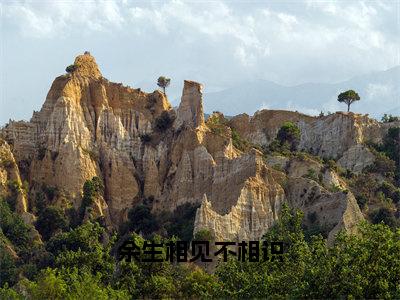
[0,0,400,124]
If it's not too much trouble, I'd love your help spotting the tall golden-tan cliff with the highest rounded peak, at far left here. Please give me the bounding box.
[3,54,170,222]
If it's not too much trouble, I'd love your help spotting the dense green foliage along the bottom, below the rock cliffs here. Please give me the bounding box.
[0,201,400,299]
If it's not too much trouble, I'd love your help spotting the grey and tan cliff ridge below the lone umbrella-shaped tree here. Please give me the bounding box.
[230,110,399,172]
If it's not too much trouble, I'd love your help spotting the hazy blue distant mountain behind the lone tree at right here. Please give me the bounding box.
[204,66,400,118]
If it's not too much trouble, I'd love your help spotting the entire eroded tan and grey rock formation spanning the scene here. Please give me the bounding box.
[0,54,387,240]
